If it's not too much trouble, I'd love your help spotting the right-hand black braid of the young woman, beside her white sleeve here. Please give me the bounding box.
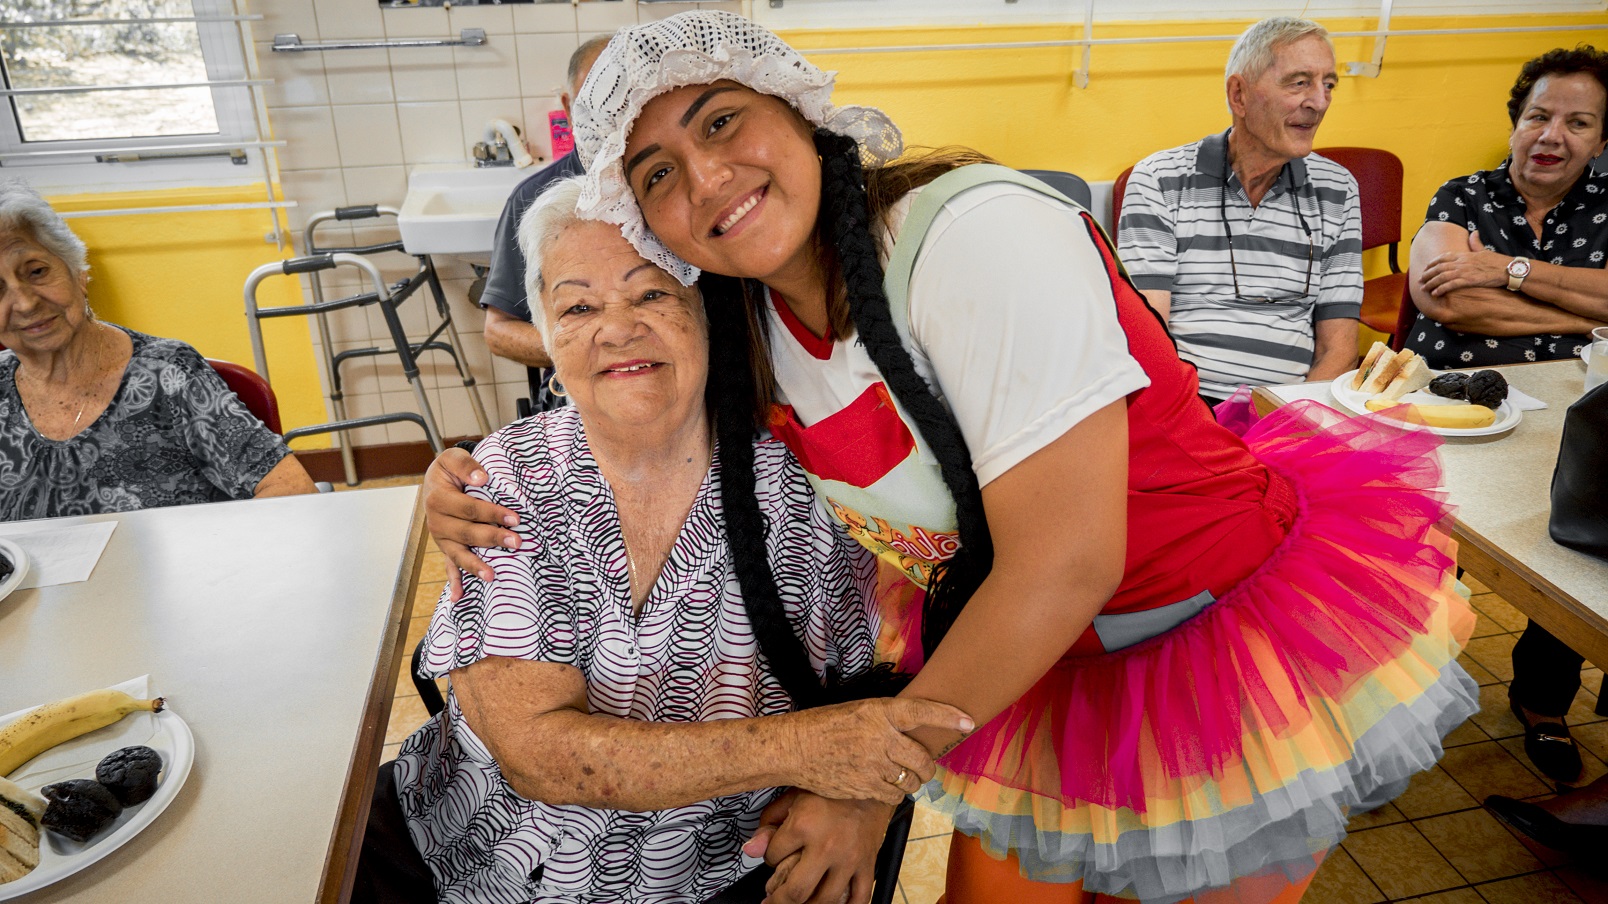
[815,129,994,656]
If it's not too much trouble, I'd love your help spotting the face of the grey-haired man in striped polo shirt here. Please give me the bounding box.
[1229,35,1339,161]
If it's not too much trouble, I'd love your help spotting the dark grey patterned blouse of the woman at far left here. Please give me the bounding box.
[0,327,291,521]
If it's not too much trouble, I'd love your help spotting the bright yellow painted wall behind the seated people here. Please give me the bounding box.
[53,8,1608,446]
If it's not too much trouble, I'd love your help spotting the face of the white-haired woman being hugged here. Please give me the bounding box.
[542,220,709,428]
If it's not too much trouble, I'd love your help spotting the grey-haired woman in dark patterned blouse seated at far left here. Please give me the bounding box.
[0,180,314,521]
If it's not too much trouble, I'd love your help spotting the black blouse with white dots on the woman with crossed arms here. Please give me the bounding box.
[1407,161,1608,367]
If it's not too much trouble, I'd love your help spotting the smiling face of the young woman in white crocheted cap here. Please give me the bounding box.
[624,80,820,281]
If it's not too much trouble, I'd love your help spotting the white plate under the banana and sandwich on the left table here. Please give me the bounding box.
[0,679,196,901]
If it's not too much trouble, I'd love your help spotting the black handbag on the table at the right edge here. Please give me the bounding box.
[1547,383,1608,558]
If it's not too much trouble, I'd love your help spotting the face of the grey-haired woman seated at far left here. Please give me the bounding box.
[0,232,88,354]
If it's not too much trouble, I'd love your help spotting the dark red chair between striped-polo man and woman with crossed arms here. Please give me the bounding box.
[1317,148,1417,347]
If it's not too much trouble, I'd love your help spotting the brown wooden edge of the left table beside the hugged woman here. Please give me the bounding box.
[318,492,425,904]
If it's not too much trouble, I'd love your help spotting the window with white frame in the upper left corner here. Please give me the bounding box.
[0,0,262,190]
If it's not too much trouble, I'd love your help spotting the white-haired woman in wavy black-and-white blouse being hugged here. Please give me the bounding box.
[354,180,971,904]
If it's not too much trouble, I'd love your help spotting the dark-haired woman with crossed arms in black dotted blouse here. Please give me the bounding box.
[1407,45,1608,367]
